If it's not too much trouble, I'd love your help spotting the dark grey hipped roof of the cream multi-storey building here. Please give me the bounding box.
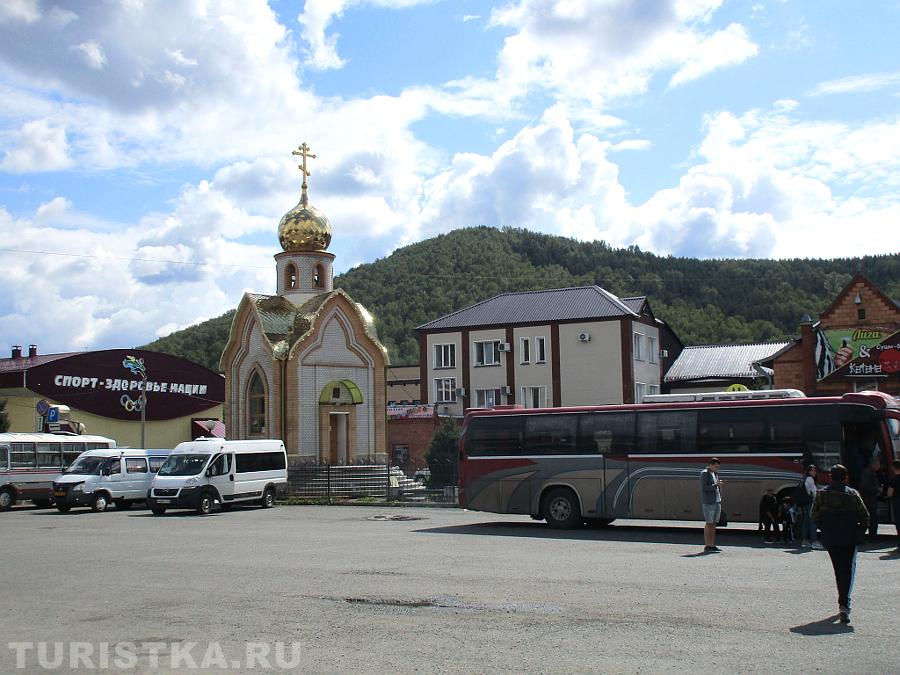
[416,286,637,331]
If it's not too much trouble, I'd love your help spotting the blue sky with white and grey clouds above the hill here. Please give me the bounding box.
[0,0,900,353]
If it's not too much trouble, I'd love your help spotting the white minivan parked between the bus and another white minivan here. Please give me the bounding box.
[53,448,172,513]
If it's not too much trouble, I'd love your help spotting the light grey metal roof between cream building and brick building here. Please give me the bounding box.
[665,342,791,382]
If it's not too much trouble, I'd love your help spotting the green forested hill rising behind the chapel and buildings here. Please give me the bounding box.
[146,227,900,370]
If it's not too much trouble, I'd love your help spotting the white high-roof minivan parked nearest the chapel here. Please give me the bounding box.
[147,438,287,515]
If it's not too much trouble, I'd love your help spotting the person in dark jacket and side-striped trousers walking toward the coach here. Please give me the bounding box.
[812,464,869,623]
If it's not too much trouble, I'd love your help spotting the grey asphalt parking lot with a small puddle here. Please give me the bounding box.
[0,506,900,673]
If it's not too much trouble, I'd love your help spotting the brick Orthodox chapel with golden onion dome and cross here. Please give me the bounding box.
[219,143,387,464]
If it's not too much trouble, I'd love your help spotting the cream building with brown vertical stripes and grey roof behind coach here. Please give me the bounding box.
[416,286,682,416]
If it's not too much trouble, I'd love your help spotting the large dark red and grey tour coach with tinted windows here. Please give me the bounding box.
[459,391,900,528]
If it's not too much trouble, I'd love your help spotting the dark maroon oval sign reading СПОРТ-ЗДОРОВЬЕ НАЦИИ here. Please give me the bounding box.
[25,349,225,421]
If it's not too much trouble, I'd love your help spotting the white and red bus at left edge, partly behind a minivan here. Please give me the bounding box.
[0,433,116,511]
